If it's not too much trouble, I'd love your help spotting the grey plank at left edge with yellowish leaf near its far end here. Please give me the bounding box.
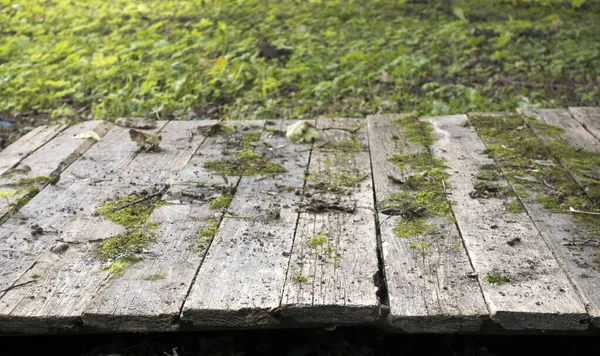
[0,121,109,221]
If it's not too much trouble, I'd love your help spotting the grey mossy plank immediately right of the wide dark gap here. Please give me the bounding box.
[367,115,488,333]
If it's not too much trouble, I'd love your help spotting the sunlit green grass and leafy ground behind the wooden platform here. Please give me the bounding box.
[0,0,600,148]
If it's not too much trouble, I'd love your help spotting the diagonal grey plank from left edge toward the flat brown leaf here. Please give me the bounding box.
[0,122,166,295]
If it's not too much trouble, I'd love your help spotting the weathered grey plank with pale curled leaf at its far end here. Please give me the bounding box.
[181,121,310,328]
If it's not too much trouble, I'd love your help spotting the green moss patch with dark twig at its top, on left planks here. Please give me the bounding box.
[93,194,167,276]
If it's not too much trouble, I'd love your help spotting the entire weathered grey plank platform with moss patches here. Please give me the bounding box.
[0,108,600,334]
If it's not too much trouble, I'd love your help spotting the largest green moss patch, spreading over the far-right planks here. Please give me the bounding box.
[470,114,600,262]
